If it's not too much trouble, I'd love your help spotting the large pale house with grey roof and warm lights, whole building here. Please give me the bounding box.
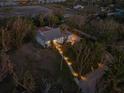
[36,27,80,47]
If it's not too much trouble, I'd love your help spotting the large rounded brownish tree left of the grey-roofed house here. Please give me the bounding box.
[7,17,35,48]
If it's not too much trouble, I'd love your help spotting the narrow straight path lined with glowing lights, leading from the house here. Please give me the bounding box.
[53,40,87,86]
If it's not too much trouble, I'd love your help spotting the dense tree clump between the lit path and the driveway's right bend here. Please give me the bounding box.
[66,39,105,75]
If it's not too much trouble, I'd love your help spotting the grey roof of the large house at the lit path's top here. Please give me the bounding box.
[37,28,71,41]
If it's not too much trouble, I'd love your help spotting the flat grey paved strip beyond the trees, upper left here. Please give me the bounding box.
[0,6,52,18]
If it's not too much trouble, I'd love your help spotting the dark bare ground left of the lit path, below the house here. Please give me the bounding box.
[11,43,77,93]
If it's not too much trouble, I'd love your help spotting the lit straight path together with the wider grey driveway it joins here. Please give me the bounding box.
[53,40,104,93]
